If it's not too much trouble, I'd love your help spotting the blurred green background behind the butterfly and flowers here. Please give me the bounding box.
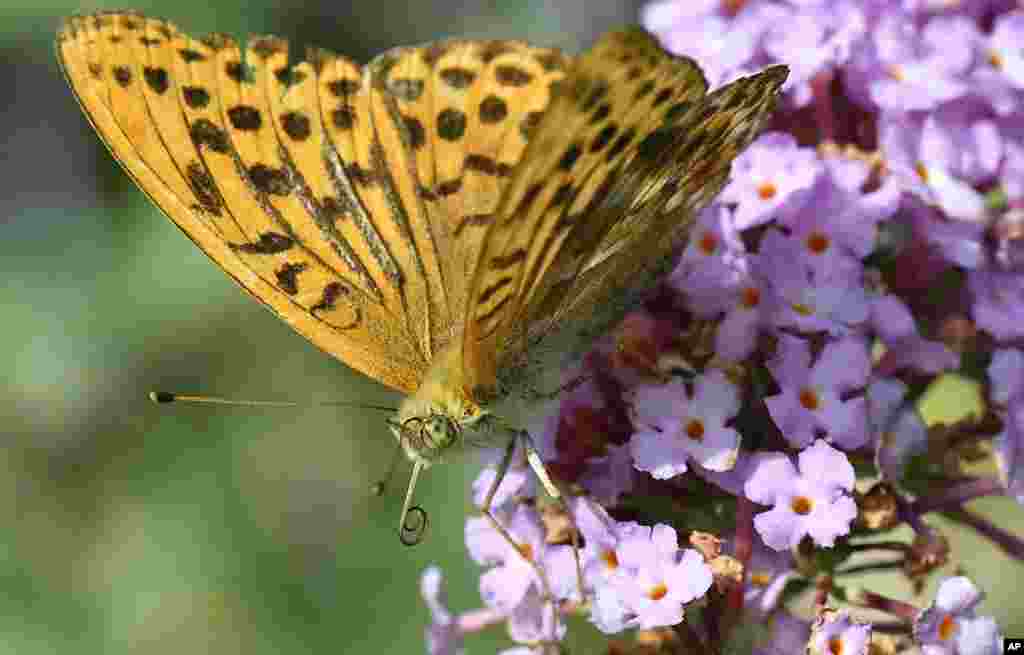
[6,0,1024,655]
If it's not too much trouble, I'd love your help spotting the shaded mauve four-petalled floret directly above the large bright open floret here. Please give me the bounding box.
[765,335,870,448]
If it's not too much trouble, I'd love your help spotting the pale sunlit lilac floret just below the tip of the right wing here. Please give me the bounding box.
[719,132,823,230]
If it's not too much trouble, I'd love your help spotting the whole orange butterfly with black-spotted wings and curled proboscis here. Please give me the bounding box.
[57,12,787,548]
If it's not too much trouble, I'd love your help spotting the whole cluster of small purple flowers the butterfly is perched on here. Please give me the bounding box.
[424,0,1024,655]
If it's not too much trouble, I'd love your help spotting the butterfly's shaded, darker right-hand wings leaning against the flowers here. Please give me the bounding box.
[464,29,785,388]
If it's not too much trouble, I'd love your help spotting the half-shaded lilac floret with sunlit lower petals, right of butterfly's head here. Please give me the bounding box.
[631,370,739,480]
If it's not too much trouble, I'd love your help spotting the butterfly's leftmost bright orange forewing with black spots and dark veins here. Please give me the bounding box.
[57,12,428,391]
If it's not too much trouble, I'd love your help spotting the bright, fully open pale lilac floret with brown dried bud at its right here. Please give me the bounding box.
[743,439,857,551]
